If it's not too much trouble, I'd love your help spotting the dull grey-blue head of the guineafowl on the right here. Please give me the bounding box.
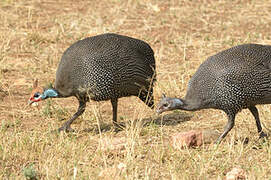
[156,94,184,114]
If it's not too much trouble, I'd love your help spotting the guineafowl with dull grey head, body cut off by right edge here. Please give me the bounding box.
[157,44,271,143]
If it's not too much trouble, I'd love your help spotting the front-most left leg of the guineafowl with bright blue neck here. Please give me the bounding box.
[58,100,86,132]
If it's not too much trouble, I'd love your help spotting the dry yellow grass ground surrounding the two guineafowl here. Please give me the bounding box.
[0,0,271,179]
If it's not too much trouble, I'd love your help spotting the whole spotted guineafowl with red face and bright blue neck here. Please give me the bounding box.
[29,34,155,131]
